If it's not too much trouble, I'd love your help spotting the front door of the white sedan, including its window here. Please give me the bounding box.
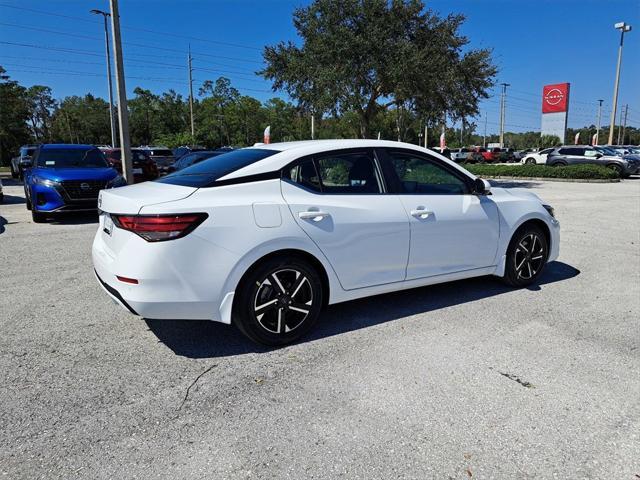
[380,149,500,280]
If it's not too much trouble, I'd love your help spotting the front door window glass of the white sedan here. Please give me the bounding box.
[387,151,469,195]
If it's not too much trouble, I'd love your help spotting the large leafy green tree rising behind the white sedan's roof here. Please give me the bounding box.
[260,0,496,137]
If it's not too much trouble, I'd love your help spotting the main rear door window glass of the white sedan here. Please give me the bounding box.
[316,152,382,194]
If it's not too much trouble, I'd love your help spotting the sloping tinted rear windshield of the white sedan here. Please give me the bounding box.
[156,148,279,188]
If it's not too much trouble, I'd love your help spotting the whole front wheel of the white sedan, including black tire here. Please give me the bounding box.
[502,224,549,287]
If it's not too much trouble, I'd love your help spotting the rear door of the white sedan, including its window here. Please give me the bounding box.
[282,149,409,290]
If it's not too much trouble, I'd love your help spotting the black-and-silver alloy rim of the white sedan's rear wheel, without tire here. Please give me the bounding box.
[253,268,313,335]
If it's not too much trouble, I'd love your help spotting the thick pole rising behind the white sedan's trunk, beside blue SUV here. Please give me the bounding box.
[109,0,133,183]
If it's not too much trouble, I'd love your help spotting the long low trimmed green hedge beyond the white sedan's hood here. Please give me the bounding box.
[464,164,619,180]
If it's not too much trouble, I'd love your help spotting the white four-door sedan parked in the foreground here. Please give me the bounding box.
[93,140,560,345]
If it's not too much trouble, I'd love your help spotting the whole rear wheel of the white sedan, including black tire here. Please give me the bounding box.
[233,256,324,346]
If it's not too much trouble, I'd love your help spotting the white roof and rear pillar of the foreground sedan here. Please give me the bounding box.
[219,139,469,180]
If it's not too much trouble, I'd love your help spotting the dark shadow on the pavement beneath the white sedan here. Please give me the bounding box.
[145,262,580,358]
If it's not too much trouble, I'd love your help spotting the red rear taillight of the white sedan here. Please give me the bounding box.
[111,213,208,242]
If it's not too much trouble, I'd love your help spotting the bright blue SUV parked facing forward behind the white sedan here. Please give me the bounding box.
[24,144,126,223]
